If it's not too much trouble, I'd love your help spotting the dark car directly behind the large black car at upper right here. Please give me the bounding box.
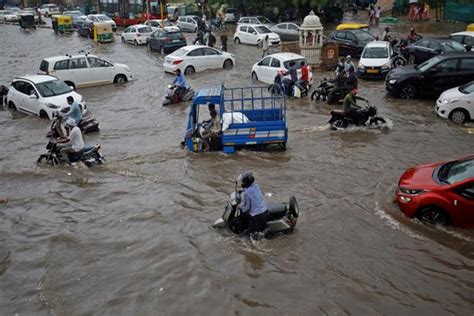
[402,38,466,65]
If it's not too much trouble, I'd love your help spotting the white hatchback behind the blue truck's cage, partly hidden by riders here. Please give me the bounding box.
[251,53,313,85]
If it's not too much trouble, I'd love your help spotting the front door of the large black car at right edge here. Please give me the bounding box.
[421,58,459,97]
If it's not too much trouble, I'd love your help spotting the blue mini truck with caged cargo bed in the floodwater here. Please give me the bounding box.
[184,86,288,154]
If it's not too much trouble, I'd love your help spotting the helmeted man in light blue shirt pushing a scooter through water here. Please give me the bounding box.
[238,171,268,237]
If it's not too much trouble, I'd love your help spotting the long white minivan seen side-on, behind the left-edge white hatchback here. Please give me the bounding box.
[40,54,133,88]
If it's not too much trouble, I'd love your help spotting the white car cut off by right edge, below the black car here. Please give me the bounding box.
[436,81,474,124]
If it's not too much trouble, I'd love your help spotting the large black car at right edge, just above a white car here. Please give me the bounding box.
[385,52,474,99]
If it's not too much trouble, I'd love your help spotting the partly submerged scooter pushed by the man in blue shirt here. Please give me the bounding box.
[213,184,299,238]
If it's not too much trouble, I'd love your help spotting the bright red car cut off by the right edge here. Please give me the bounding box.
[396,155,474,228]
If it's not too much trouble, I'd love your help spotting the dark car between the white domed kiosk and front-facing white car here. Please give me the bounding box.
[331,30,375,57]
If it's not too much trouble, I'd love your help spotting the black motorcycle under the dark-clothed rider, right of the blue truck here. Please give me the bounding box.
[328,101,386,130]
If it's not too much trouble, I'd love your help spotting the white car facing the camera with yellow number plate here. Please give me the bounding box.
[357,41,394,78]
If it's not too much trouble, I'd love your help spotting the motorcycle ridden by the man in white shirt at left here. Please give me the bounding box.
[36,139,105,167]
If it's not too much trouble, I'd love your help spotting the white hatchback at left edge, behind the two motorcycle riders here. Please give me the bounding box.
[6,75,85,120]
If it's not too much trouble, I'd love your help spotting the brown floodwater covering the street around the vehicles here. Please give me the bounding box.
[0,18,474,315]
